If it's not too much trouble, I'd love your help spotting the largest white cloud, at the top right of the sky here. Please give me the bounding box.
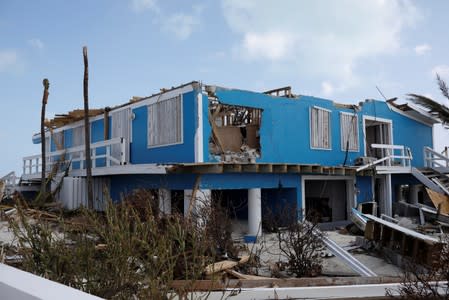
[222,0,420,92]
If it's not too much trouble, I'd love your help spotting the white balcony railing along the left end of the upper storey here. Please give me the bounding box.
[23,138,127,175]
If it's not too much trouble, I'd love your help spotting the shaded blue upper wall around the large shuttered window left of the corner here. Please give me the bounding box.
[130,91,197,164]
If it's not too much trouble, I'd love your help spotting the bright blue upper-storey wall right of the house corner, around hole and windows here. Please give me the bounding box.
[208,88,432,166]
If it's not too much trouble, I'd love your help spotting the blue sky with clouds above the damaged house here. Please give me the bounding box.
[0,0,449,177]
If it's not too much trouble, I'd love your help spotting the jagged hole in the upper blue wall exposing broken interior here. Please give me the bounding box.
[209,98,262,162]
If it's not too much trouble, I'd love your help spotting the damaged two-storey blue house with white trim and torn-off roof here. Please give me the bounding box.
[21,82,447,240]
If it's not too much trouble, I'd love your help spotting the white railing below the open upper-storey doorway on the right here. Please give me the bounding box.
[357,144,413,172]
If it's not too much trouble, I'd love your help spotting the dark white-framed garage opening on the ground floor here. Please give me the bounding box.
[304,180,348,223]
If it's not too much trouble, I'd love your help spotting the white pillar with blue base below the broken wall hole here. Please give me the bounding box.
[245,189,262,243]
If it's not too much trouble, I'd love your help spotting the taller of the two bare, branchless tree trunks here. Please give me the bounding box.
[83,46,94,209]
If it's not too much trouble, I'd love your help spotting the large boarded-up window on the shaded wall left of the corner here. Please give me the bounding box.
[148,96,182,147]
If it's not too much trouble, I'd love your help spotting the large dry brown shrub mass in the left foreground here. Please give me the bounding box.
[10,193,214,299]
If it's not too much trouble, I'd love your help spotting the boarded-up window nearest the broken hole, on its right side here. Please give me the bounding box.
[310,107,331,149]
